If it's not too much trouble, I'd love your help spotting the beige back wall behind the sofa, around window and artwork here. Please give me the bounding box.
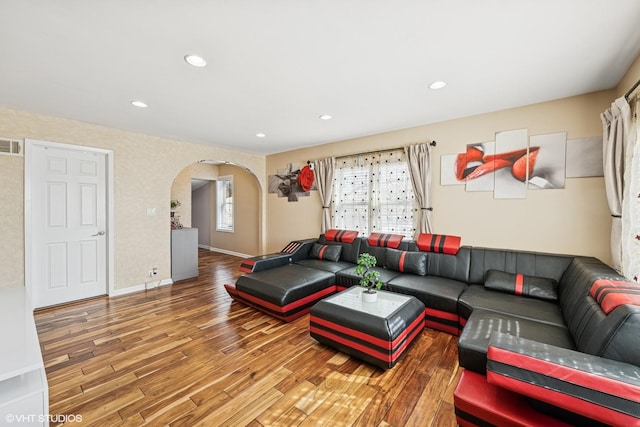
[267,91,615,262]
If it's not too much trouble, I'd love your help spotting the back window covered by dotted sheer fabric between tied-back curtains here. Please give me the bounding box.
[332,149,416,238]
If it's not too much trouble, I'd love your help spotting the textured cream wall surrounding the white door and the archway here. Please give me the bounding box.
[0,108,266,289]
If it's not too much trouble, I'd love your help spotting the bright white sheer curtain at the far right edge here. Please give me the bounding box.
[622,97,640,282]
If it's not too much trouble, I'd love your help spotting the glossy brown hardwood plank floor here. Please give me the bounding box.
[35,250,460,427]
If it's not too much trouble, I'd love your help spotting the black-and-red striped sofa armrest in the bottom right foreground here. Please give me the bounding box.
[487,333,640,425]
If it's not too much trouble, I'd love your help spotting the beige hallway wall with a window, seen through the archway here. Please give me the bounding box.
[211,165,262,255]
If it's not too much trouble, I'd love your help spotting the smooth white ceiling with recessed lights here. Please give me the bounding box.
[0,0,640,154]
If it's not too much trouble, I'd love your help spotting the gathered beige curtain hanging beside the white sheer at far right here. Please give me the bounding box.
[600,97,631,274]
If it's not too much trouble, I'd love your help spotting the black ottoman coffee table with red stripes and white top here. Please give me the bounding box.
[309,286,424,369]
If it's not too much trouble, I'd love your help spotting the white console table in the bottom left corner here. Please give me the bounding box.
[0,287,49,426]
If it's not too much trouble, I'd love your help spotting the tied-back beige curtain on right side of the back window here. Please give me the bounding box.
[404,144,432,239]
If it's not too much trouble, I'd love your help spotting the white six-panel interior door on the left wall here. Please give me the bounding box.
[29,143,108,308]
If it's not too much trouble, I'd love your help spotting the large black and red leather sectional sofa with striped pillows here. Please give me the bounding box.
[226,230,640,426]
